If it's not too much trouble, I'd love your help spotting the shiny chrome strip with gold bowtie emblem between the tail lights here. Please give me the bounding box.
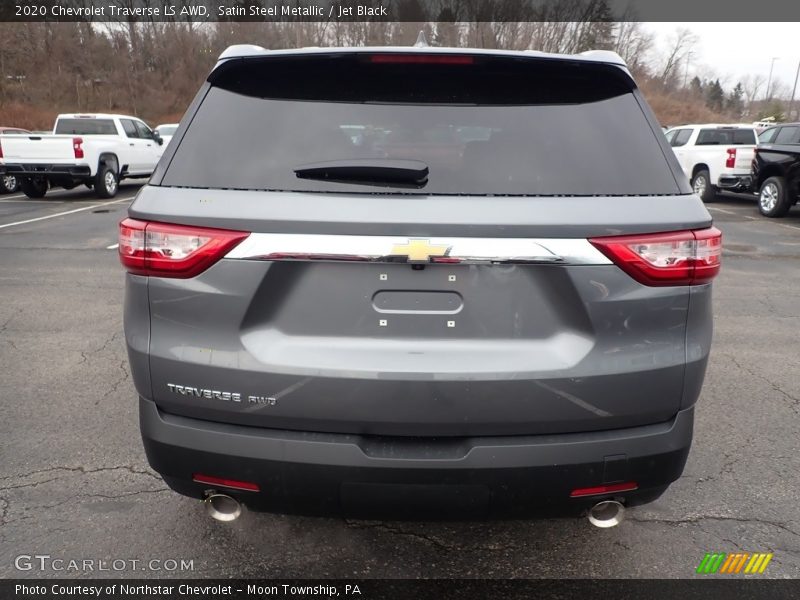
[225,233,611,265]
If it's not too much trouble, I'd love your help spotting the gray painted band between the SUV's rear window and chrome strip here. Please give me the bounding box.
[128,185,711,239]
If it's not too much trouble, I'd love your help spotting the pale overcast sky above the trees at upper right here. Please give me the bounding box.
[643,22,800,97]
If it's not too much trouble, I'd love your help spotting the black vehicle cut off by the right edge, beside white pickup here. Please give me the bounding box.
[752,123,800,217]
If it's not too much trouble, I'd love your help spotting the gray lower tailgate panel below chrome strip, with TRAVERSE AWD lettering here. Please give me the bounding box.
[136,254,707,435]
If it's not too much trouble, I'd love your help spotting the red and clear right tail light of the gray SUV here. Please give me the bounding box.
[589,227,722,286]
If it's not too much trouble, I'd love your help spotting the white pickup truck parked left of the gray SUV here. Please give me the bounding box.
[0,114,164,198]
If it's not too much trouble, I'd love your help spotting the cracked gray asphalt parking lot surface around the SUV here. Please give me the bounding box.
[0,184,800,578]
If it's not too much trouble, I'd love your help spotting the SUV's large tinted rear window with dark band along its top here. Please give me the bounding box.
[162,54,679,195]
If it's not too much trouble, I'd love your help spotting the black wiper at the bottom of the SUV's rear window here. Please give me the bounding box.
[294,158,428,188]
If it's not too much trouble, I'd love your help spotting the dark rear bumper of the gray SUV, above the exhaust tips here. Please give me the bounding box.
[140,399,694,516]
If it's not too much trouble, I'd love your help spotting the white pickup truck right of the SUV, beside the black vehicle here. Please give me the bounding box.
[664,124,757,202]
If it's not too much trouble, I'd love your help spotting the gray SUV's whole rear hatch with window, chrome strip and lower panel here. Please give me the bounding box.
[130,52,710,436]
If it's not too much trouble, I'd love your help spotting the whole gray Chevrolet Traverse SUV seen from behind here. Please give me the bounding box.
[120,46,721,514]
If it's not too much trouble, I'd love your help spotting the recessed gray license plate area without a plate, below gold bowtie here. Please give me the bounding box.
[245,261,585,343]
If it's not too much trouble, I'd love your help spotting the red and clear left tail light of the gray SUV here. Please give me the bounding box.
[119,219,250,279]
